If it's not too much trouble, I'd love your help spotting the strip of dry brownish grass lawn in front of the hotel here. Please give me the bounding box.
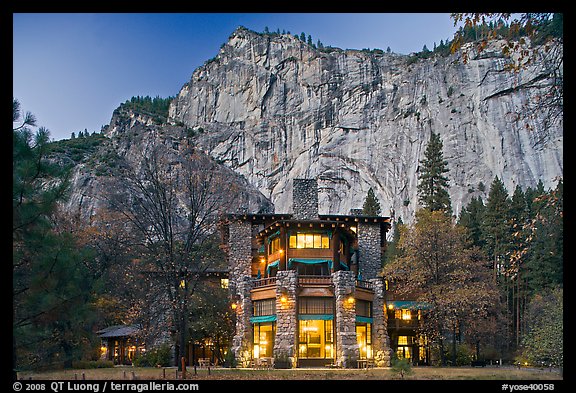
[18,367,563,381]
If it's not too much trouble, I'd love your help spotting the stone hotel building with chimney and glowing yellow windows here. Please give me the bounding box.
[224,179,398,367]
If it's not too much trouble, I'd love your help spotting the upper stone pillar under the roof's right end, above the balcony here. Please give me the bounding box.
[358,222,382,280]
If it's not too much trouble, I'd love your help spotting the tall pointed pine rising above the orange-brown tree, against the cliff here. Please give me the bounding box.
[418,132,452,215]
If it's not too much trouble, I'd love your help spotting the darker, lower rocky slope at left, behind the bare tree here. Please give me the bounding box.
[64,105,274,221]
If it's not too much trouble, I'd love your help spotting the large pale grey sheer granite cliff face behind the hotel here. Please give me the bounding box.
[169,28,563,222]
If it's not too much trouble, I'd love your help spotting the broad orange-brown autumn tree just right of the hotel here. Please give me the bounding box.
[383,209,498,365]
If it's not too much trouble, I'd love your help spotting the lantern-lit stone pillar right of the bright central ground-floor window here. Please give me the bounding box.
[332,270,359,368]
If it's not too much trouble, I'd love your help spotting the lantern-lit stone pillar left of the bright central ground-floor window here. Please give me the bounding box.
[274,270,298,359]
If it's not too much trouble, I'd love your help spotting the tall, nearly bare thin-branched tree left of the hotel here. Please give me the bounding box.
[102,141,235,368]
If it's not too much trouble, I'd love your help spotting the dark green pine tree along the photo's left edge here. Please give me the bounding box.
[12,100,94,370]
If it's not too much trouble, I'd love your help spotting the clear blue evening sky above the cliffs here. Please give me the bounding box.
[13,13,456,140]
